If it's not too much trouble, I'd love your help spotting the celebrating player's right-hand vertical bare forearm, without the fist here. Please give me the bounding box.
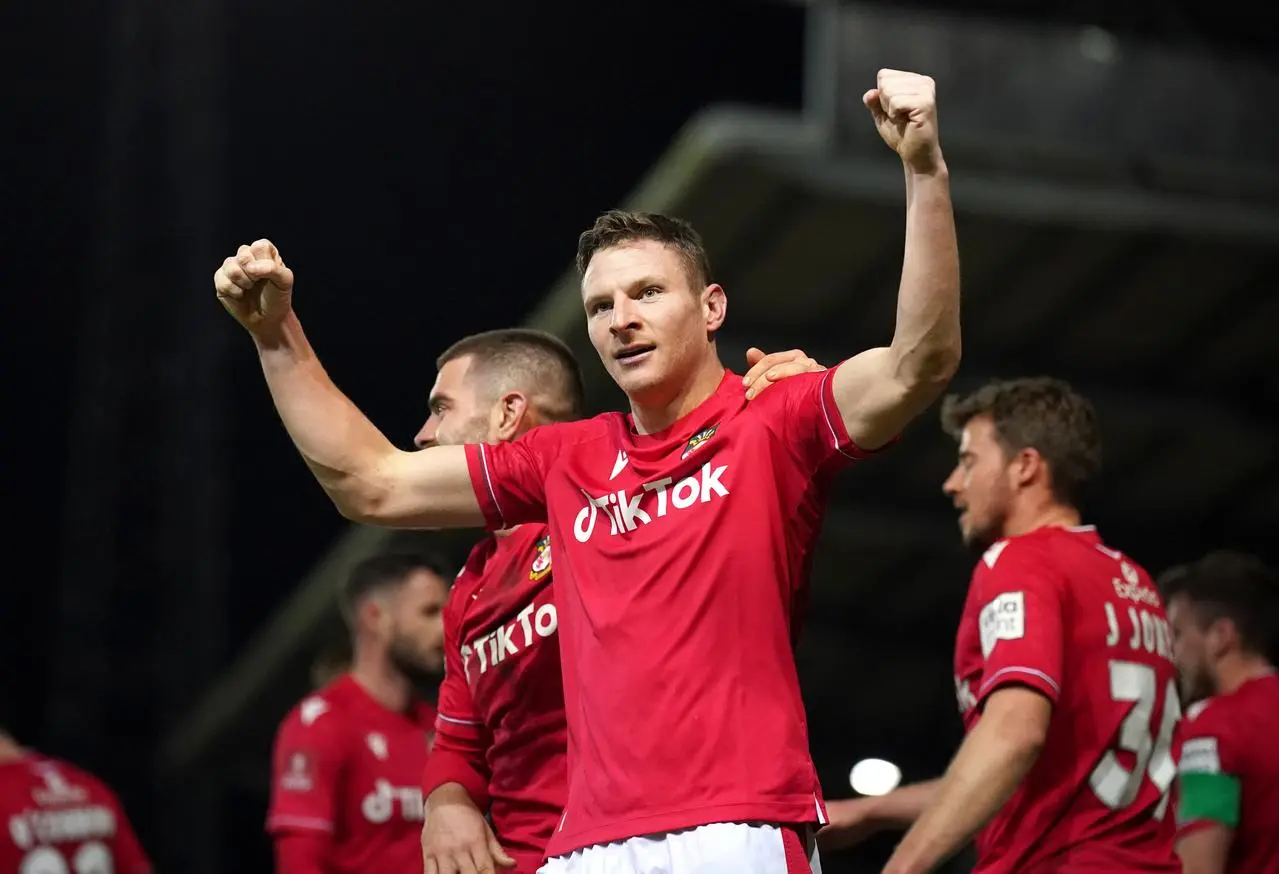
[890,164,961,390]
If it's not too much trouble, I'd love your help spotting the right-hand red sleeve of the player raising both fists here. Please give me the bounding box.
[752,362,891,472]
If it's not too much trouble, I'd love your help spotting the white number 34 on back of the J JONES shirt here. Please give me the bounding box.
[1088,662,1182,819]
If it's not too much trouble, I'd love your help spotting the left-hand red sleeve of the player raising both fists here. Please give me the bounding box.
[467,425,570,531]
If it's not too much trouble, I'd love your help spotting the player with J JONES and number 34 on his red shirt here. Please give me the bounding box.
[821,379,1181,874]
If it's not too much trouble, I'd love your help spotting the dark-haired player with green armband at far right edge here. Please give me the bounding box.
[1159,552,1279,874]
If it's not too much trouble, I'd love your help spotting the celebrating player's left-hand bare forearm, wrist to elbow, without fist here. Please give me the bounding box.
[253,315,399,518]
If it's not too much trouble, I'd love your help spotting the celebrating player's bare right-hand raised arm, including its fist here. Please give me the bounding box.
[831,70,961,449]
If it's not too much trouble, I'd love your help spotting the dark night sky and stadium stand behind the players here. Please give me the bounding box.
[0,0,1279,874]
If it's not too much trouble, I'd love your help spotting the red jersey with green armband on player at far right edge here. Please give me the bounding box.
[1178,673,1279,874]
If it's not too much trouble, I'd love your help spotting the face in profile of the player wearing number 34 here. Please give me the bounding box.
[941,416,1013,549]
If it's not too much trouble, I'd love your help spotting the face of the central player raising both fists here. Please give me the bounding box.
[582,239,728,406]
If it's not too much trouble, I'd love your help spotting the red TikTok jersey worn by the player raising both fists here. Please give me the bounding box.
[467,370,862,856]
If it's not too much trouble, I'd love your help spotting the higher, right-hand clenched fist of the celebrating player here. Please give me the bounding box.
[862,70,941,173]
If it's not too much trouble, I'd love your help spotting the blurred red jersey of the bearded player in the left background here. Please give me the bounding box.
[266,674,435,874]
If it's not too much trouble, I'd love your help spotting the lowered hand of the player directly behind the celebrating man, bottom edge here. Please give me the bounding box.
[422,786,515,874]
